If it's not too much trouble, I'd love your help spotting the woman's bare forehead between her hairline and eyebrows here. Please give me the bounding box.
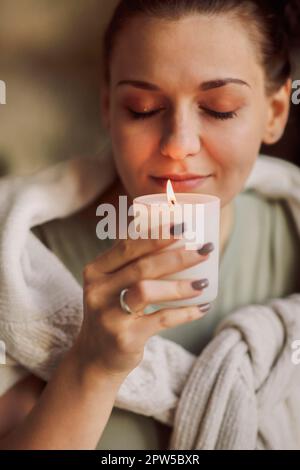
[111,14,262,89]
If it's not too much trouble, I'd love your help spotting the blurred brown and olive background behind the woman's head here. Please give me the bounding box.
[0,0,300,176]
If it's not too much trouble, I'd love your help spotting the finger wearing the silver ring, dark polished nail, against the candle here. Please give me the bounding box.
[125,279,209,315]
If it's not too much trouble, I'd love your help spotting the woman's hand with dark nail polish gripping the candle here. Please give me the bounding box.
[78,226,213,379]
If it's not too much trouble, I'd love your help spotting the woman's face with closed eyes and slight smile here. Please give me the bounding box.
[104,15,288,207]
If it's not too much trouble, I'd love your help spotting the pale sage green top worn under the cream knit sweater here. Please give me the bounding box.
[33,186,300,450]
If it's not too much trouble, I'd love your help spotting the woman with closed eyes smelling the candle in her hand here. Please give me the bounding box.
[0,0,299,449]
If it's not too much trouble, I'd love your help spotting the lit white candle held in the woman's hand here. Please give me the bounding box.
[133,181,220,308]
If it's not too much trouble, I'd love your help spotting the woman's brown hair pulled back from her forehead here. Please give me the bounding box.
[103,0,300,92]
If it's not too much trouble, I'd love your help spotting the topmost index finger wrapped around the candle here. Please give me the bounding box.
[84,224,184,282]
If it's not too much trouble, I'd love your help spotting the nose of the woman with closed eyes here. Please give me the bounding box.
[161,109,201,160]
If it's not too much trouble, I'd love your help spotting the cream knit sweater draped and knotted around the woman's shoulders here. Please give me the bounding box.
[0,156,300,449]
